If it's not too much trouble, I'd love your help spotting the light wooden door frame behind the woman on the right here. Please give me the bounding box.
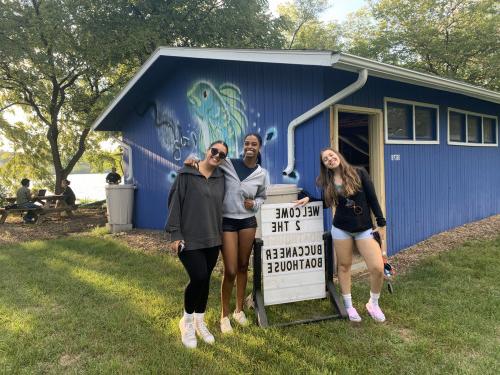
[330,104,386,216]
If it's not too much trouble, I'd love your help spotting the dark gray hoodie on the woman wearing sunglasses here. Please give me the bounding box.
[165,167,224,250]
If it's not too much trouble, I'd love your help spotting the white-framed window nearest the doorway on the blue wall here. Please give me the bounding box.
[384,98,439,144]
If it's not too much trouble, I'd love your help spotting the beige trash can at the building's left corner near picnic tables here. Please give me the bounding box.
[106,184,135,233]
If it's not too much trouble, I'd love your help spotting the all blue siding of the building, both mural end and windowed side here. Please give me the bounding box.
[122,59,500,253]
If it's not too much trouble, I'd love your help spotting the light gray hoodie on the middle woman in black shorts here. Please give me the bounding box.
[220,159,269,219]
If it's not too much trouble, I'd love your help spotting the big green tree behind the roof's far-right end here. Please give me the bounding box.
[345,0,500,90]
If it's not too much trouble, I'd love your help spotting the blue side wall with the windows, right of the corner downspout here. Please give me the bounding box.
[326,71,500,254]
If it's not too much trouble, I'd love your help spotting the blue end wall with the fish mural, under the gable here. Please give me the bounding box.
[122,60,329,228]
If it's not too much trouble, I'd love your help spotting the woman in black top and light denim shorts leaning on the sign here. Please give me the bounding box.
[297,148,386,322]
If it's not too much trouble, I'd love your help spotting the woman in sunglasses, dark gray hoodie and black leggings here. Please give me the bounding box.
[165,141,228,348]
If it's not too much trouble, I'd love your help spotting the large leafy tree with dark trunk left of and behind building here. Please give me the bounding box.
[0,0,282,192]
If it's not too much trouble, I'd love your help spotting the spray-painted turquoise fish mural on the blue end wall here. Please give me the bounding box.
[145,79,288,183]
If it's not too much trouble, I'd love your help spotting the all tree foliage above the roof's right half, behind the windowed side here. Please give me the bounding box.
[279,0,500,90]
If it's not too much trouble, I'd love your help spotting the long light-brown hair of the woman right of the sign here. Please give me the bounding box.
[316,147,361,207]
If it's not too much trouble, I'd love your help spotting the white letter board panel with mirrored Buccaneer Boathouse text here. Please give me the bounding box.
[261,202,326,305]
